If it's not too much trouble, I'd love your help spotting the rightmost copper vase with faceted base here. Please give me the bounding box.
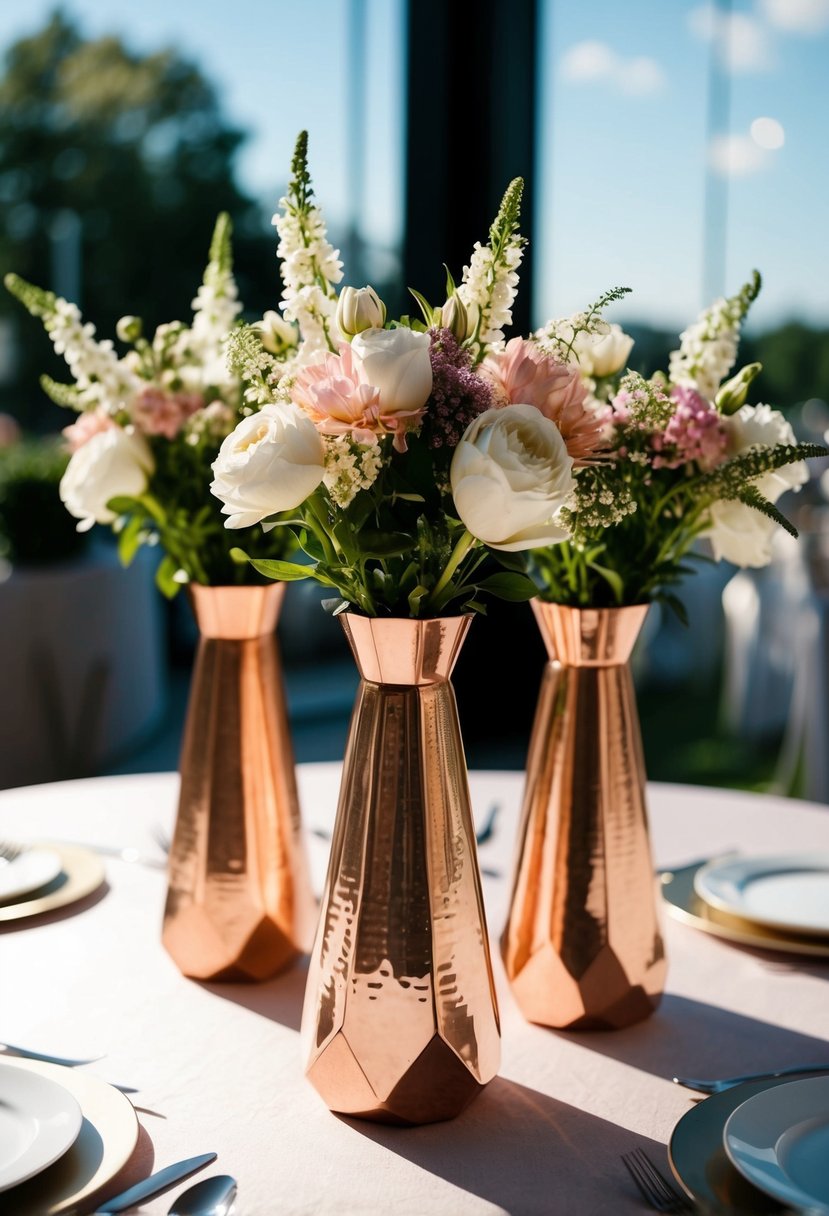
[501,599,666,1030]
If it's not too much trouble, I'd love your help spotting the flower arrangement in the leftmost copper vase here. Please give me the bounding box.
[5,221,291,596]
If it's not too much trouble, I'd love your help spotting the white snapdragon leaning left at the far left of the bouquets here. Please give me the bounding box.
[44,295,141,413]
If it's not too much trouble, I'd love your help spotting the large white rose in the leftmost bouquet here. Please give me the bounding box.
[60,427,156,531]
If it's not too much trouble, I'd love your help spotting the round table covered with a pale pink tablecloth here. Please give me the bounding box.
[0,764,829,1216]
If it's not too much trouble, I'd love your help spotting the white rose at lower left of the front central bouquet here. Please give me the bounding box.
[210,404,326,528]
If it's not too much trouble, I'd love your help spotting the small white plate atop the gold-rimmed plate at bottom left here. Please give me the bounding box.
[0,1064,81,1190]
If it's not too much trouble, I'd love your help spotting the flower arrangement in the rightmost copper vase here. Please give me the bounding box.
[532,271,825,617]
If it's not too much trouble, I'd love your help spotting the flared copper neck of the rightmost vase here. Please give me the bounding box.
[532,599,649,668]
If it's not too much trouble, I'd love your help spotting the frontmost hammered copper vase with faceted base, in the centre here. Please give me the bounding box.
[303,614,500,1124]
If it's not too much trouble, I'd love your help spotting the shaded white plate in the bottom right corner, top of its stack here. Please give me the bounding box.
[723,1076,829,1214]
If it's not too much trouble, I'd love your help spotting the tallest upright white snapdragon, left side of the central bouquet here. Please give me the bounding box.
[272,198,343,360]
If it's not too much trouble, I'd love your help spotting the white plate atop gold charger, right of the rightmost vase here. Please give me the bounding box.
[694,852,829,936]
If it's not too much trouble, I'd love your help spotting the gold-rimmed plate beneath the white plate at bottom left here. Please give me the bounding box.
[0,1059,139,1216]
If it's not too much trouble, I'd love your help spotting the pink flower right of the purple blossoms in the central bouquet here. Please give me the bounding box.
[480,338,608,465]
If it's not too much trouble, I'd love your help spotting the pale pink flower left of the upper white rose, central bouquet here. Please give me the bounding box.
[291,342,423,452]
